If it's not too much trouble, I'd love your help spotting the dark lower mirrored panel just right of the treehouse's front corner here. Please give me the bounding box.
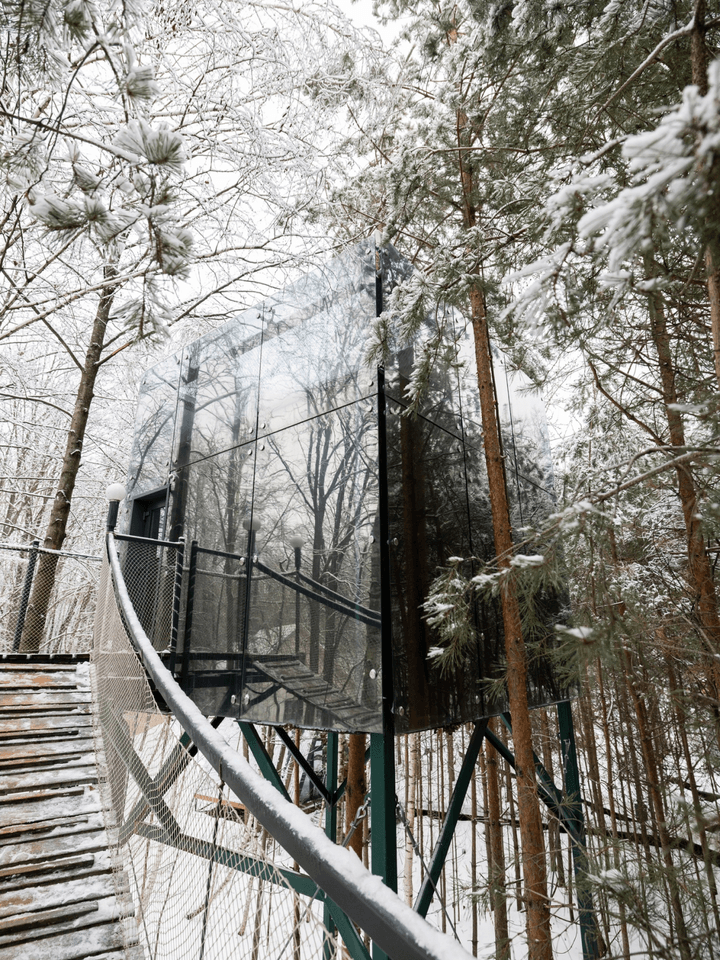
[386,401,495,732]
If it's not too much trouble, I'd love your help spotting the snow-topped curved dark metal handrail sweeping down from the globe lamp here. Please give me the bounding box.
[107,533,470,960]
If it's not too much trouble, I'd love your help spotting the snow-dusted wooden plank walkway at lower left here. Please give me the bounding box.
[0,655,143,960]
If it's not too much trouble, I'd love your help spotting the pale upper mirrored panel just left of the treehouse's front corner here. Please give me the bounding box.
[259,248,376,433]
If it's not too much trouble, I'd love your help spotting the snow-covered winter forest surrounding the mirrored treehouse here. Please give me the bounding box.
[0,0,720,960]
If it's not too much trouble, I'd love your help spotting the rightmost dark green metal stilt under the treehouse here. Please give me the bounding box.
[557,700,600,960]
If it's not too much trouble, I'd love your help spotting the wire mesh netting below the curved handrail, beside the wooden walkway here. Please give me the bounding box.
[93,558,337,960]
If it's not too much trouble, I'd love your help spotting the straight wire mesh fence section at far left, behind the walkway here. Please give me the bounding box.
[0,540,100,655]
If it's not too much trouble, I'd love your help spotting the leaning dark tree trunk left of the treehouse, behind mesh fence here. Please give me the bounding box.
[20,265,117,653]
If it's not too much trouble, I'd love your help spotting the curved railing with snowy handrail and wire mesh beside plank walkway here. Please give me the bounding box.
[93,536,476,960]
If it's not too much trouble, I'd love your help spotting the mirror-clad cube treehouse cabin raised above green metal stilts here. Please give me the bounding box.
[117,242,564,733]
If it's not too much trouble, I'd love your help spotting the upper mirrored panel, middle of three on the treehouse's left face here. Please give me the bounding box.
[175,310,262,469]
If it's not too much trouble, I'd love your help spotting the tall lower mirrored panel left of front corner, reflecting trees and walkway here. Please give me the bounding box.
[243,400,381,731]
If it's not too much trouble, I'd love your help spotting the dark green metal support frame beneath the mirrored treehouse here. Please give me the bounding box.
[100,680,600,960]
